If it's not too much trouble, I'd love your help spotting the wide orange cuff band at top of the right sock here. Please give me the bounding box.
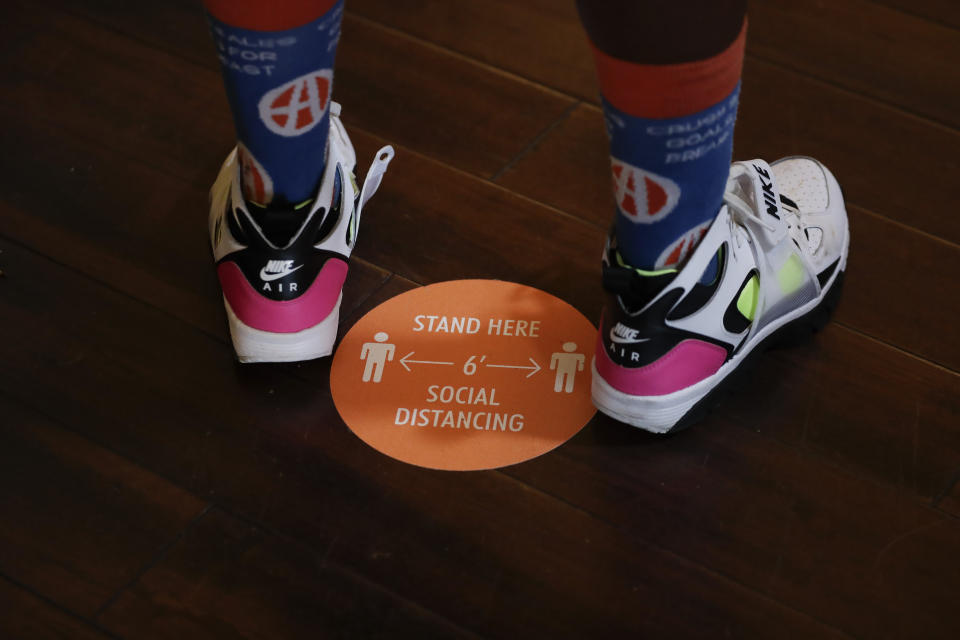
[591,19,747,119]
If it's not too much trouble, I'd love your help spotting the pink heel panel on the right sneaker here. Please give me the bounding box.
[595,325,727,396]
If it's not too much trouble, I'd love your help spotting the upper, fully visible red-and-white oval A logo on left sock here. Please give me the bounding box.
[257,69,333,137]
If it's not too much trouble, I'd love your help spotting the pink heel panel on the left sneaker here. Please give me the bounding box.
[217,258,347,333]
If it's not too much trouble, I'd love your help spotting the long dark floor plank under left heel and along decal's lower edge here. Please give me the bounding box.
[0,242,848,637]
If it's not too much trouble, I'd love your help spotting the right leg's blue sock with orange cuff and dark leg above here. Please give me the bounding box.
[578,0,746,275]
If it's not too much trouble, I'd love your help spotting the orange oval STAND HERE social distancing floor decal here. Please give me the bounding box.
[330,280,596,471]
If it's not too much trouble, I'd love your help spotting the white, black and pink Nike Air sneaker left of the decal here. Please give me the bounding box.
[209,102,393,362]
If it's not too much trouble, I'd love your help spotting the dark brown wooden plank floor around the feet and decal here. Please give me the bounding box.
[0,0,960,640]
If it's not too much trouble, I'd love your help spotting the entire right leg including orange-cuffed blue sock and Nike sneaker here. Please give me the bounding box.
[578,0,849,433]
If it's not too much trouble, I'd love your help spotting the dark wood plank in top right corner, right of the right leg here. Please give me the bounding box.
[747,0,960,127]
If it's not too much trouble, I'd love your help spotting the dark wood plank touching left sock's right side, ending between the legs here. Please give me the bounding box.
[335,16,574,177]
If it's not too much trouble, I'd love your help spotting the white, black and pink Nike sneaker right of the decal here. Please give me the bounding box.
[593,157,850,433]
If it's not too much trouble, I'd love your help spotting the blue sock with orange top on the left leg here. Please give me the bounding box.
[204,0,343,206]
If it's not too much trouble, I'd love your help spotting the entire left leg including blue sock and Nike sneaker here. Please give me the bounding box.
[204,0,393,362]
